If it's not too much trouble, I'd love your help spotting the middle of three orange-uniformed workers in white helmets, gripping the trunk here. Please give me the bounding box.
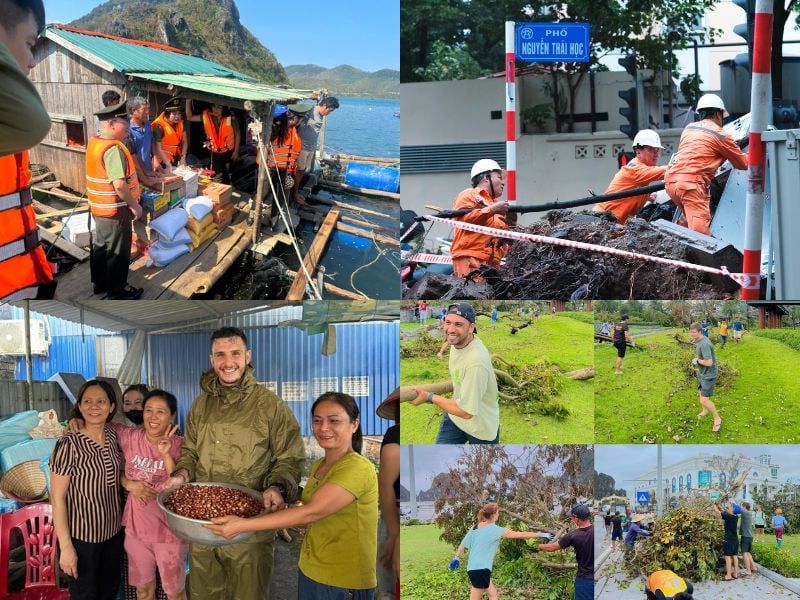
[592,129,667,224]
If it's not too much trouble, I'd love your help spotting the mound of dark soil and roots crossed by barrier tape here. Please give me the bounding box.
[403,210,730,300]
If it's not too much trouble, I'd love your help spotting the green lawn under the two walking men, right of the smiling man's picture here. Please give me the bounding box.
[594,329,800,444]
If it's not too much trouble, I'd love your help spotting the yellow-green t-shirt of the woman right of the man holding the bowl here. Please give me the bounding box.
[298,452,378,590]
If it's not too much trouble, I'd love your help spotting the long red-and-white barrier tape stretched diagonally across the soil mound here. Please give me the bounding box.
[425,215,750,286]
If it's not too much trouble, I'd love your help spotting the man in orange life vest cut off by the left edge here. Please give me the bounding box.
[0,0,56,302]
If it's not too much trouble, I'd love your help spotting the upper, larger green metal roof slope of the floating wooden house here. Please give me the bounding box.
[45,25,255,81]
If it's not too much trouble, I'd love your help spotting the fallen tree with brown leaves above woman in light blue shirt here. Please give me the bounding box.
[435,445,594,569]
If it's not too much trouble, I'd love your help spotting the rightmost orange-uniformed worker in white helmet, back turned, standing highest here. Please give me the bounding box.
[664,94,747,235]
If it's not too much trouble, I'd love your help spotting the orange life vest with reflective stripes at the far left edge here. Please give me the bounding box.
[0,151,53,302]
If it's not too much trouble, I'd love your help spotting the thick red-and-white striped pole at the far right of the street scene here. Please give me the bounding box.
[742,0,784,300]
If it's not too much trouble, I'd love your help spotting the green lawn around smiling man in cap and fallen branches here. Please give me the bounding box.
[400,313,594,444]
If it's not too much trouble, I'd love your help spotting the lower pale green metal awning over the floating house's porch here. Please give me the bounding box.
[128,72,311,102]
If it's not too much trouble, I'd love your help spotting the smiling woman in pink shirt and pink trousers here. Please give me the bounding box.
[115,390,189,600]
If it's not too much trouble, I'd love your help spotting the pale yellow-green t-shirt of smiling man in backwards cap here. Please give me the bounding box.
[449,337,500,440]
